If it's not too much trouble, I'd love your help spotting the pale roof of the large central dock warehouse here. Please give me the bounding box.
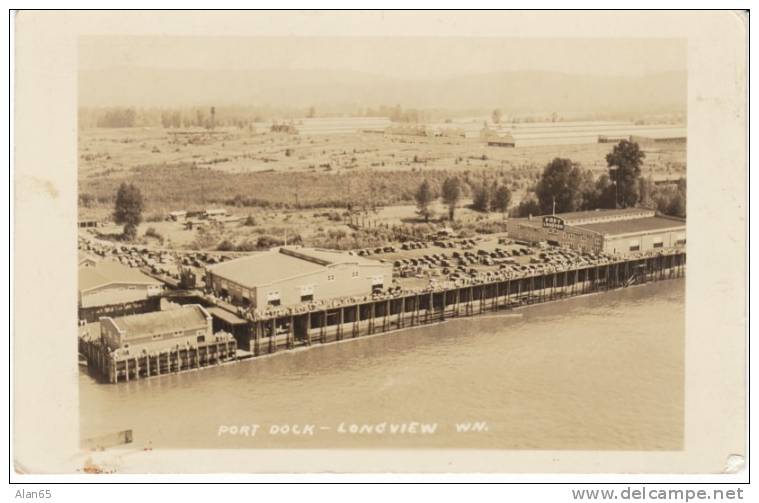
[209,247,380,288]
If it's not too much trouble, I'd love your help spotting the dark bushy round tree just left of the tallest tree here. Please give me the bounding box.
[535,157,583,213]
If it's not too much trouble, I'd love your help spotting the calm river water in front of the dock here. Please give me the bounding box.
[80,280,685,450]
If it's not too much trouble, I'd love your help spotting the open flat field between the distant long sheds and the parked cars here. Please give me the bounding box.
[79,127,686,254]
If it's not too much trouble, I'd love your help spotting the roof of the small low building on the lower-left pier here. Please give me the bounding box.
[107,304,208,338]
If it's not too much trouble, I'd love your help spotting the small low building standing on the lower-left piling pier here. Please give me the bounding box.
[99,304,213,353]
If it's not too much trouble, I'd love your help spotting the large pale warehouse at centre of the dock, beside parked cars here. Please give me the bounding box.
[206,247,393,308]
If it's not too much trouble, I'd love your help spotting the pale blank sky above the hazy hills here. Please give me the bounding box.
[79,37,687,79]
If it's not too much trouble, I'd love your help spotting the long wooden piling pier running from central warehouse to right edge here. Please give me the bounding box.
[226,251,685,356]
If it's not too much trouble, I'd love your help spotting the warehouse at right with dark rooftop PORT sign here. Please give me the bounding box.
[507,208,686,253]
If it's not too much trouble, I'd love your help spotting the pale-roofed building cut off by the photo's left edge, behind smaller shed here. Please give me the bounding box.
[79,260,163,321]
